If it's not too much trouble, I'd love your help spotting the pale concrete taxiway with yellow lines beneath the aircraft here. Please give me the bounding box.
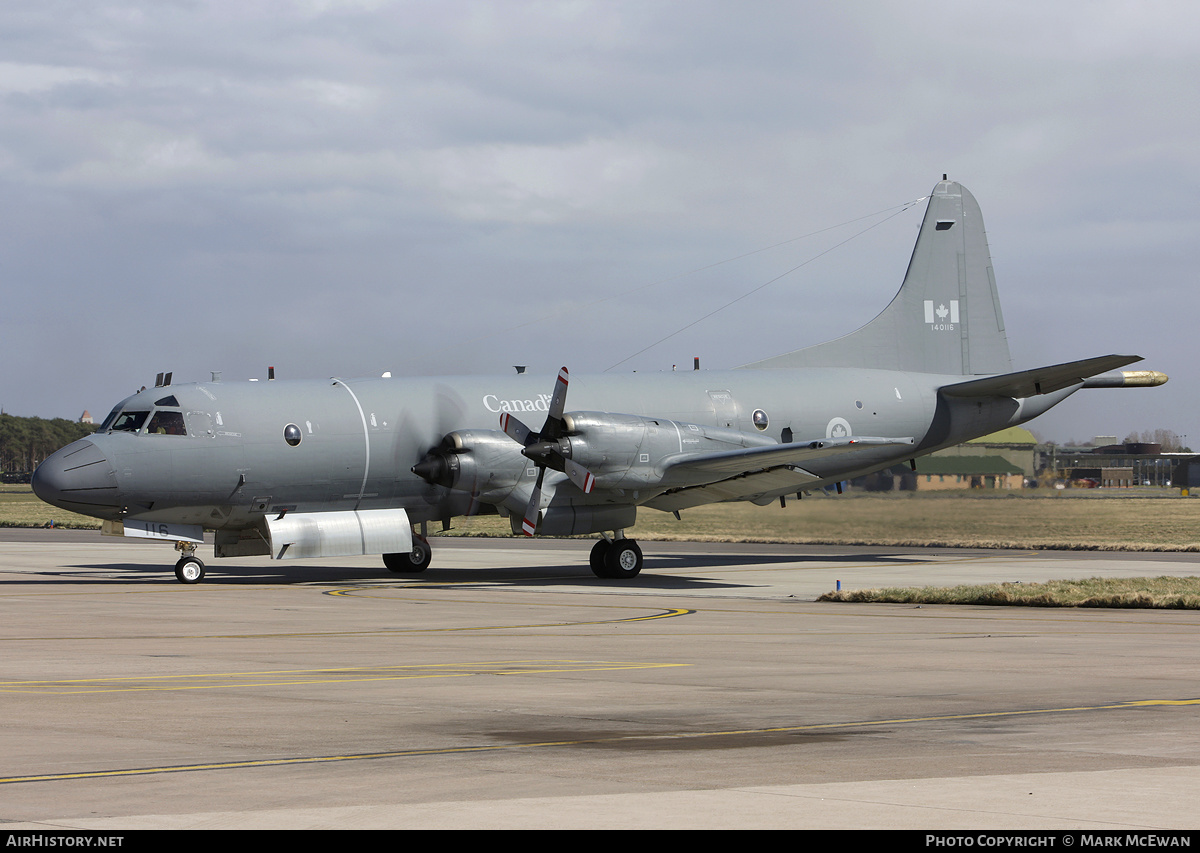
[0,530,1200,830]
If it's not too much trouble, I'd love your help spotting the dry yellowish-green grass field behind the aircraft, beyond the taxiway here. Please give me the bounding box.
[7,485,1200,551]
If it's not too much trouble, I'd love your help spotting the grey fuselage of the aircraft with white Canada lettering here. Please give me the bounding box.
[40,368,1074,529]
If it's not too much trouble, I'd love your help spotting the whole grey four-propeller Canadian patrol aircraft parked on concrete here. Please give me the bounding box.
[32,176,1166,583]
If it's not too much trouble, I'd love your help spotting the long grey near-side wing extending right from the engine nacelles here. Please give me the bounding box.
[646,437,913,512]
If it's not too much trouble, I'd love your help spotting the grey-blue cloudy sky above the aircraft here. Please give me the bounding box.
[0,0,1200,444]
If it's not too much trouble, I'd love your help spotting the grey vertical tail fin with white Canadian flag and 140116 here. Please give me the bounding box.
[745,180,1013,376]
